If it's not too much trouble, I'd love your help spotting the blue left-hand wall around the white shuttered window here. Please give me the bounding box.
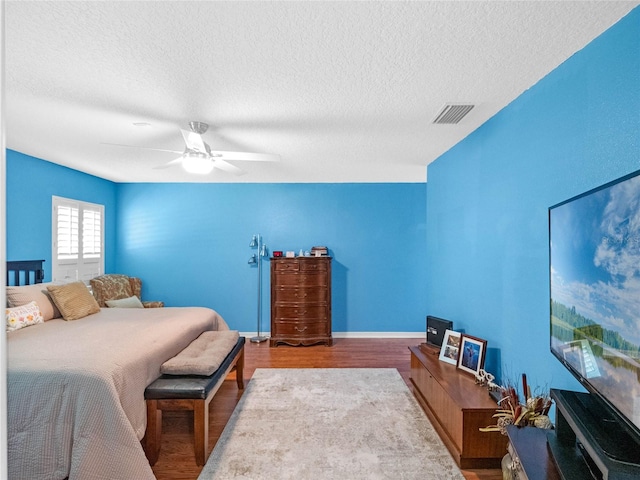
[6,150,117,282]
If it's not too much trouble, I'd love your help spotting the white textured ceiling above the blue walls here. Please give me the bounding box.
[5,0,639,182]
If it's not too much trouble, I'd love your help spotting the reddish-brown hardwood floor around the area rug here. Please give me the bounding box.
[153,338,506,480]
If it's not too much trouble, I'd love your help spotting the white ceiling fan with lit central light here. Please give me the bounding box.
[104,122,280,175]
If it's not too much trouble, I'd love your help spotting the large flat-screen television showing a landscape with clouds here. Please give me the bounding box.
[549,172,640,433]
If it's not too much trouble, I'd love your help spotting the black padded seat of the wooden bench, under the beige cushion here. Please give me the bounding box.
[144,337,245,400]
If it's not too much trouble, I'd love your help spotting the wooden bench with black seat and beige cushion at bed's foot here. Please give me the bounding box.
[143,332,245,465]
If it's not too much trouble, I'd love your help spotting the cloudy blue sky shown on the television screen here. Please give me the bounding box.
[551,176,640,345]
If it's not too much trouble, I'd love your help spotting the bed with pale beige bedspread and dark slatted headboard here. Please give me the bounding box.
[7,262,228,480]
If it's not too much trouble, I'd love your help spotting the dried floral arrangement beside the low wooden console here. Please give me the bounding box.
[480,373,553,435]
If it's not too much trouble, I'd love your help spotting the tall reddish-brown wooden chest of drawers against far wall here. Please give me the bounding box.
[270,257,333,347]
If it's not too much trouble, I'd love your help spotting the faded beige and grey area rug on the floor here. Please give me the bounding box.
[198,368,464,480]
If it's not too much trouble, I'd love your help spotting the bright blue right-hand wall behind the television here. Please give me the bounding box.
[427,8,640,389]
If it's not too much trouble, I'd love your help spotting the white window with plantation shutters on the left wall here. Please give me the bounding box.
[52,196,104,283]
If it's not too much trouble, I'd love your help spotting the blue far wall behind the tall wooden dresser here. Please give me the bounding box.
[116,183,427,332]
